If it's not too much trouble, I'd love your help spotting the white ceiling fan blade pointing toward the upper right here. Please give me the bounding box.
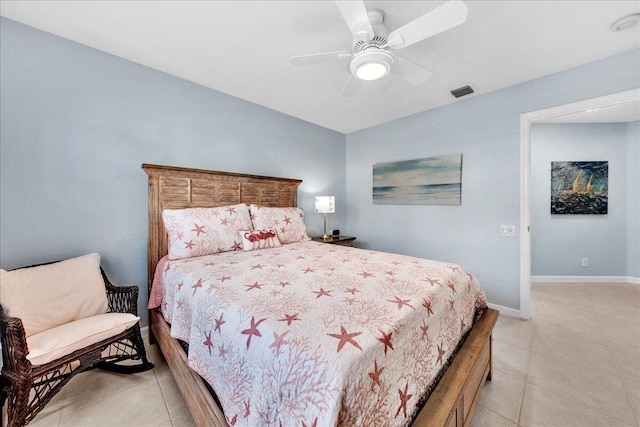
[388,0,469,49]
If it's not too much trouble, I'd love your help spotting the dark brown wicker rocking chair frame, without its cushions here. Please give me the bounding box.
[0,257,153,427]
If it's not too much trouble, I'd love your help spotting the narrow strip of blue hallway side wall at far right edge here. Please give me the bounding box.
[627,121,640,278]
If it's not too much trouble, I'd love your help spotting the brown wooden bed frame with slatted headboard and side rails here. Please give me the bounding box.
[142,164,498,427]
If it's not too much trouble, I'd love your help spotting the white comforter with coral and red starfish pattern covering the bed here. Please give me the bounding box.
[152,241,486,427]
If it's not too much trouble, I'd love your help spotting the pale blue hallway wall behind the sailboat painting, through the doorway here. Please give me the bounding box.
[531,123,640,276]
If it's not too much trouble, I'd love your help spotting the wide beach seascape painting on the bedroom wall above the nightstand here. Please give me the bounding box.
[373,154,462,205]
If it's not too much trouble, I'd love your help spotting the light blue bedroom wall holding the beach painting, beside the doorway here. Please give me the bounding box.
[347,50,640,308]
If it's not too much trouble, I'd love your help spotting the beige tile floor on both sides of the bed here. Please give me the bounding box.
[22,283,640,427]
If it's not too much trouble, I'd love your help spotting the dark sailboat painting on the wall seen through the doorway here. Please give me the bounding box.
[551,162,609,215]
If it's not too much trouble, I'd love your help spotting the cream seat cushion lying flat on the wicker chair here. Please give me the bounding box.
[27,313,140,366]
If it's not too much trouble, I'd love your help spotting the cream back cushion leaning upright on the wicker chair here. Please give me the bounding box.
[0,254,108,337]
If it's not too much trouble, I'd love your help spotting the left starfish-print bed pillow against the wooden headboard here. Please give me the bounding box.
[162,203,252,260]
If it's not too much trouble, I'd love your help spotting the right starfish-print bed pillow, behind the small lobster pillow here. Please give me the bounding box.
[249,205,311,244]
